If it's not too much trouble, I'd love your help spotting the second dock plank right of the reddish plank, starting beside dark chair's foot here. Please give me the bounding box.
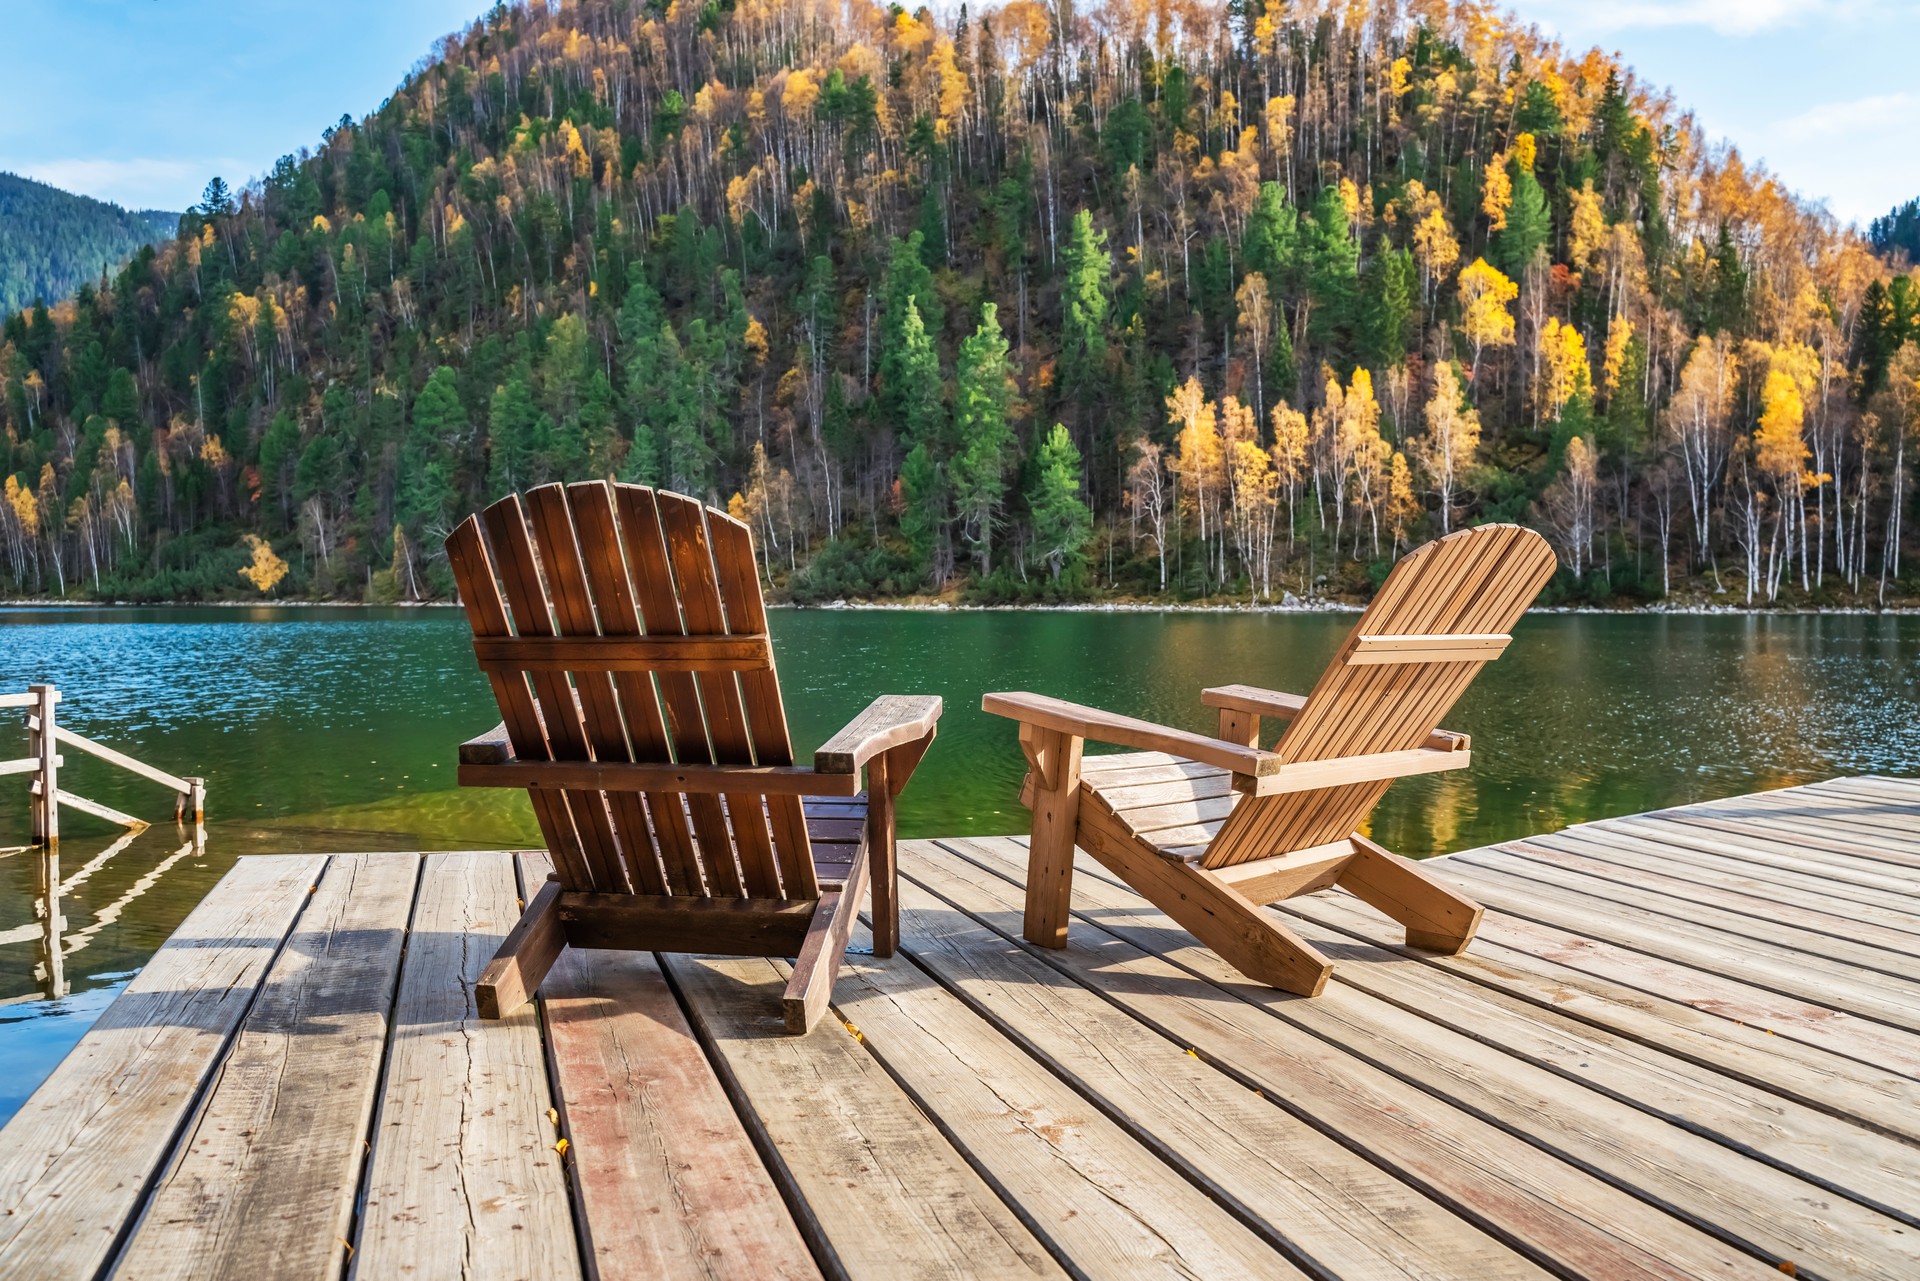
[839,933,1306,1281]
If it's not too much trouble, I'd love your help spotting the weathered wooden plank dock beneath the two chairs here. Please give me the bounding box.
[0,778,1920,1281]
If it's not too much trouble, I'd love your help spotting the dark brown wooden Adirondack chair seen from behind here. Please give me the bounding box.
[447,482,941,1033]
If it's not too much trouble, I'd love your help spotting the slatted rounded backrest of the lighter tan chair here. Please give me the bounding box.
[1204,524,1555,868]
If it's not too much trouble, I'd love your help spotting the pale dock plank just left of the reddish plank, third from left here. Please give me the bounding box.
[353,855,580,1281]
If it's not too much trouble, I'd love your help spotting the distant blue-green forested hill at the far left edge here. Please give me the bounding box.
[0,173,180,313]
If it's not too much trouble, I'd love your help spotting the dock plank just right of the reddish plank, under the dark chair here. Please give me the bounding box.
[664,956,1066,1281]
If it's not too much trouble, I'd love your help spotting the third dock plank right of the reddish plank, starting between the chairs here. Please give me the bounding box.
[894,843,1540,1281]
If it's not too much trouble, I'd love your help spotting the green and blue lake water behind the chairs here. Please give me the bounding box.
[0,607,1920,1122]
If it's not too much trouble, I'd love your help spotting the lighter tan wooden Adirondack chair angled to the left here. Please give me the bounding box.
[983,524,1553,997]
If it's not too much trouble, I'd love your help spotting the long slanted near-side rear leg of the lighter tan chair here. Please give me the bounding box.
[1081,805,1332,997]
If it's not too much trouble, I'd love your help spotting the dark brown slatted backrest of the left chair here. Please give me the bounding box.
[447,482,820,899]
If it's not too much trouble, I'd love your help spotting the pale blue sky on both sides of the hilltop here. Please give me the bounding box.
[0,0,1920,223]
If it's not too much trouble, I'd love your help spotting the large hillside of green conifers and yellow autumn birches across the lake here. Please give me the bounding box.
[0,0,1920,603]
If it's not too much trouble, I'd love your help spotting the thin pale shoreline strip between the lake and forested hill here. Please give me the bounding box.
[0,597,1920,618]
